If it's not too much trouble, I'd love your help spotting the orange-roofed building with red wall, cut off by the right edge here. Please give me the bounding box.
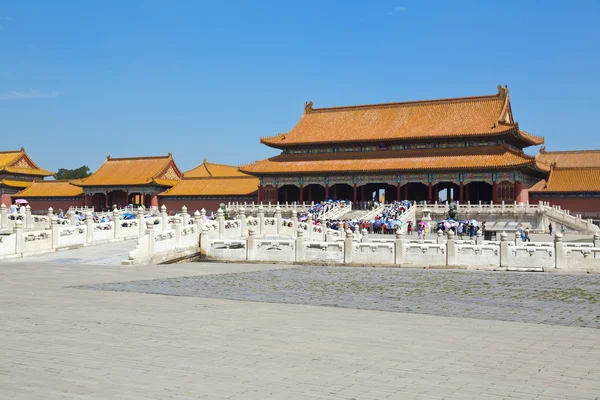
[529,147,600,219]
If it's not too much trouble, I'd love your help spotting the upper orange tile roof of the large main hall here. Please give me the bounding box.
[261,86,544,148]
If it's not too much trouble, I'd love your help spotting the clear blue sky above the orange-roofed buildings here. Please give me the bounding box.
[0,0,600,170]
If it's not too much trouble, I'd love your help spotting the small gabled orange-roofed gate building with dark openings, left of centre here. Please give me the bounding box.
[74,153,181,210]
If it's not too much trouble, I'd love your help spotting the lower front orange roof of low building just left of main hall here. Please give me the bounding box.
[160,175,259,197]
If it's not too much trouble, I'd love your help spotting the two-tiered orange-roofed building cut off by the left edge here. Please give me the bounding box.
[0,147,54,206]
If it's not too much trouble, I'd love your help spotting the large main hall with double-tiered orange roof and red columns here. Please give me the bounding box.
[240,86,550,203]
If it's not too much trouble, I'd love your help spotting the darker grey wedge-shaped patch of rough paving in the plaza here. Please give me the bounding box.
[80,267,600,328]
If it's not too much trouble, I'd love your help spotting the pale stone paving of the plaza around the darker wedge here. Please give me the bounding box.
[0,255,600,400]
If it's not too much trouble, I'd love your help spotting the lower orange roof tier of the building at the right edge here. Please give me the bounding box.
[529,167,600,193]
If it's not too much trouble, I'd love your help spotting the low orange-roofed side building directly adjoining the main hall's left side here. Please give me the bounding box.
[159,160,258,213]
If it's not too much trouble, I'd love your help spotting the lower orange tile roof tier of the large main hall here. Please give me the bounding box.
[240,146,548,175]
